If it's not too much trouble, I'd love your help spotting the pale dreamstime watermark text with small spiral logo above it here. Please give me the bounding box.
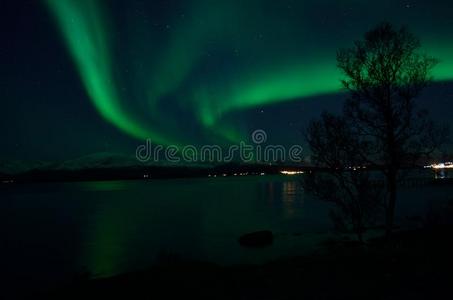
[135,129,303,163]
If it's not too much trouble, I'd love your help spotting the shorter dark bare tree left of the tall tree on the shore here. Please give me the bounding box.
[304,113,382,242]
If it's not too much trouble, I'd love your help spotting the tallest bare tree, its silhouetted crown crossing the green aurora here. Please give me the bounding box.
[337,23,446,235]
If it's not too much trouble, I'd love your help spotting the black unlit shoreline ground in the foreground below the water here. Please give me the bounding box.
[33,226,453,299]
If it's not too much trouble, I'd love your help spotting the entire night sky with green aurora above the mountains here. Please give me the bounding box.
[0,0,453,160]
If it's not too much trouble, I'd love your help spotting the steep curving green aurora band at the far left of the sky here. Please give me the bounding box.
[47,0,173,143]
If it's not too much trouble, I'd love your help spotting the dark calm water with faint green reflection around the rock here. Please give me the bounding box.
[0,176,453,296]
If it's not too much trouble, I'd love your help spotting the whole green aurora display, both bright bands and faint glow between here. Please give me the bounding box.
[45,0,453,145]
